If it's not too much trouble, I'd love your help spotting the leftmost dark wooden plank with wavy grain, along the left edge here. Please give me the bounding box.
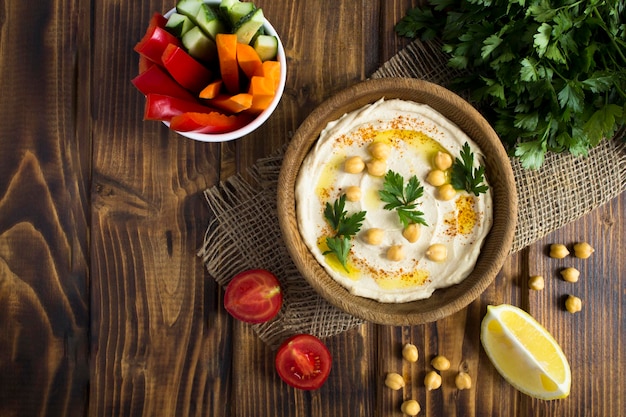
[0,1,90,416]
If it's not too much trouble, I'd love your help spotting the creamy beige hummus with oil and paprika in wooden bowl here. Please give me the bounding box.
[295,99,492,303]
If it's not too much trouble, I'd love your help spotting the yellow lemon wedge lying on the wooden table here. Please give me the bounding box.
[480,304,572,400]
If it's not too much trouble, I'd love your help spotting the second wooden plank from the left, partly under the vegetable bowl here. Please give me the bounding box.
[89,2,231,416]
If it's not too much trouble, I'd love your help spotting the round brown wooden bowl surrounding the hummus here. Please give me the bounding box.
[277,78,517,325]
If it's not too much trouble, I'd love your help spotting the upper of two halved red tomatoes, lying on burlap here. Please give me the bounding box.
[224,269,283,323]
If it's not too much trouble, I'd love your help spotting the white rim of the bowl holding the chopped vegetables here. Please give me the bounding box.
[163,0,287,142]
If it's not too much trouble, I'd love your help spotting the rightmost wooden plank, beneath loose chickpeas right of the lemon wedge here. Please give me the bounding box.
[528,193,626,416]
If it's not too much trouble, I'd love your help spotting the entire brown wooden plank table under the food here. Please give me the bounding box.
[0,0,626,417]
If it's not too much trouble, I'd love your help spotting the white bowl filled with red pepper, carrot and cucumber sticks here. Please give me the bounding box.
[132,0,286,142]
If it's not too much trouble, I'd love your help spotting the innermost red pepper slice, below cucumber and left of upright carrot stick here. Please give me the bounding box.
[161,44,211,93]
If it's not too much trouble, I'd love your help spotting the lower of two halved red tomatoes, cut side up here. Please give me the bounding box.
[275,334,332,390]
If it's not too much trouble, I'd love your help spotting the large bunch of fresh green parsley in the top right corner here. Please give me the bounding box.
[395,0,626,168]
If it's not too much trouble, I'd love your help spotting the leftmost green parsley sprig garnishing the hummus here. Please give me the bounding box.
[323,194,365,272]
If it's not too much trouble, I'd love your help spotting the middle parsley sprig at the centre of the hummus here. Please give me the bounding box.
[378,170,428,227]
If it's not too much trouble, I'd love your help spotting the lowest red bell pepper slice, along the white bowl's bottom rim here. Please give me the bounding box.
[170,111,250,133]
